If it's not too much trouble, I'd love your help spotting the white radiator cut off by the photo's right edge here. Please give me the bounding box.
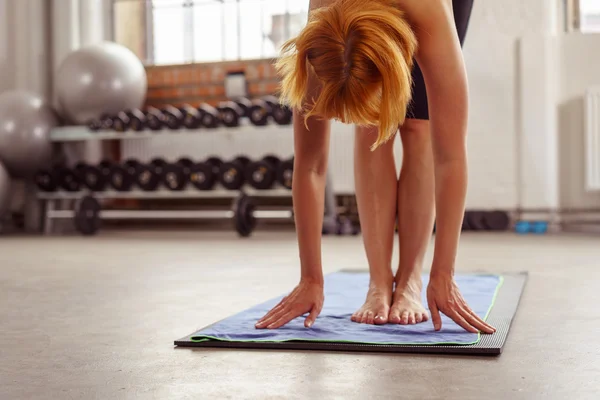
[585,86,600,191]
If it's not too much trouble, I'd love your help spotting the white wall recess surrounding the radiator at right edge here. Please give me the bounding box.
[557,33,600,209]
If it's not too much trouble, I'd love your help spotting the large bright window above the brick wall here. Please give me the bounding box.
[113,0,309,65]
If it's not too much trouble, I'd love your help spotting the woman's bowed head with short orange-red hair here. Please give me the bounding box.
[277,0,417,148]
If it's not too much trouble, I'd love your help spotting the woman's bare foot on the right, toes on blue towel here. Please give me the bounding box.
[389,275,429,325]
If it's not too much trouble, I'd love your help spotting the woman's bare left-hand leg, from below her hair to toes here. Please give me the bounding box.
[352,127,397,324]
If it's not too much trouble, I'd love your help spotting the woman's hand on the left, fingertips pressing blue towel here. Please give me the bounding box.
[256,280,324,329]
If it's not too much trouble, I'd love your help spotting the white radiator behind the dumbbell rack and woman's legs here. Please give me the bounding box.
[121,122,401,195]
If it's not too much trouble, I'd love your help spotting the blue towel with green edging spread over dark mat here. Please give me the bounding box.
[191,272,502,345]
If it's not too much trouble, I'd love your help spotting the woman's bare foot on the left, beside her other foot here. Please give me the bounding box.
[351,280,394,325]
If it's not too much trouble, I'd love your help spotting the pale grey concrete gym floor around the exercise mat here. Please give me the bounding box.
[0,232,600,400]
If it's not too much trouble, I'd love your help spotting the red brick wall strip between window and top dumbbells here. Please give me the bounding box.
[146,59,279,107]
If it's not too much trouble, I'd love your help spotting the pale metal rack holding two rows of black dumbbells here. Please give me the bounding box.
[38,124,338,234]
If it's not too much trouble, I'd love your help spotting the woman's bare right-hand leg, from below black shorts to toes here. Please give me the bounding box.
[389,119,435,324]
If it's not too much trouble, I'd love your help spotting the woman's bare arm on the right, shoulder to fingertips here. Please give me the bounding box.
[412,0,495,333]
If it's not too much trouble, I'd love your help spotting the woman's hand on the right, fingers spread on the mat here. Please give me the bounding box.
[427,275,496,333]
